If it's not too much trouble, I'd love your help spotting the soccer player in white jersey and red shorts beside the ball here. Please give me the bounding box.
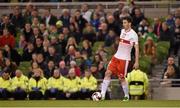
[101,17,139,101]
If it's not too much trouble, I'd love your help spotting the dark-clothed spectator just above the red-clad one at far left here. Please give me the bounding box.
[0,15,16,36]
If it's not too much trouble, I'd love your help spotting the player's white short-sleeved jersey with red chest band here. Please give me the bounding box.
[114,29,138,60]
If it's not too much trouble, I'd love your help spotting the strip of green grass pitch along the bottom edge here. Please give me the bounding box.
[0,100,180,107]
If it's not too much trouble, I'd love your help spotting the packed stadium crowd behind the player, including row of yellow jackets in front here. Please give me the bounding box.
[0,1,180,100]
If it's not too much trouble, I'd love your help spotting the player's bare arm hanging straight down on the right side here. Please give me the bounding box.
[133,44,139,69]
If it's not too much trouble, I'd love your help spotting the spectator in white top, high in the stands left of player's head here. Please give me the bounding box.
[81,4,92,22]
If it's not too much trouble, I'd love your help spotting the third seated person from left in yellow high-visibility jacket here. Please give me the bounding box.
[29,69,47,100]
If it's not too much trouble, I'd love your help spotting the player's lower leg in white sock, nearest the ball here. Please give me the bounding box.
[101,70,112,99]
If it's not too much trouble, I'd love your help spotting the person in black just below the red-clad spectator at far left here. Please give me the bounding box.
[4,45,21,66]
